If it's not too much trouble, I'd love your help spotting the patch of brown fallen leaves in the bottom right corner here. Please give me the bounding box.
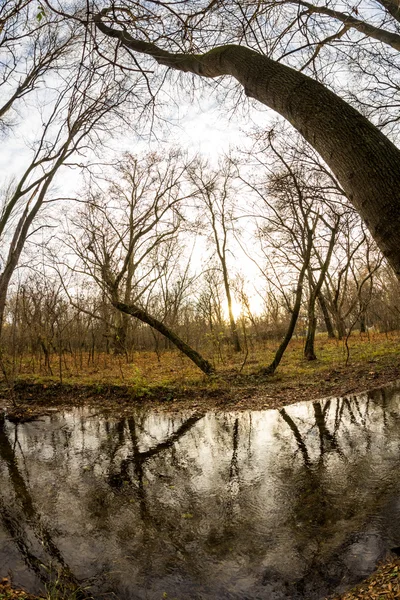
[332,558,400,600]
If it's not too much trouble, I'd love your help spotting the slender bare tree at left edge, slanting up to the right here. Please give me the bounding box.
[0,63,135,338]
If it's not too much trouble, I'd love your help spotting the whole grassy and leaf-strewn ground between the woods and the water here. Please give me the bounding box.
[0,332,400,422]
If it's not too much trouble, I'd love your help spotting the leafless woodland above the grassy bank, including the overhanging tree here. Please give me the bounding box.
[0,0,400,396]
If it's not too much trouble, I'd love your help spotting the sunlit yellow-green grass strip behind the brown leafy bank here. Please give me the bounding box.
[7,332,400,395]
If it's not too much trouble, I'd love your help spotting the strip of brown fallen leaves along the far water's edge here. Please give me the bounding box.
[4,357,400,422]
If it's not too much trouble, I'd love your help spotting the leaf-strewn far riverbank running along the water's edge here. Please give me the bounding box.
[0,340,400,420]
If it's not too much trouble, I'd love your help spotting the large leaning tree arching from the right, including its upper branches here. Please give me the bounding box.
[86,0,400,278]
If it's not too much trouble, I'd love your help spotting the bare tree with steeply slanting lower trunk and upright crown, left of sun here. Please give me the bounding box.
[73,151,213,374]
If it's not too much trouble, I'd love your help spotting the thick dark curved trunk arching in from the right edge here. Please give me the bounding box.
[94,14,400,278]
